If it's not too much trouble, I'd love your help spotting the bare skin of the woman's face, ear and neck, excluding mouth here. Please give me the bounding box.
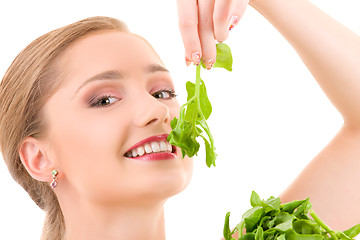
[22,31,192,240]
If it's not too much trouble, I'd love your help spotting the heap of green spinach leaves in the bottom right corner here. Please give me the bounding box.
[224,192,360,240]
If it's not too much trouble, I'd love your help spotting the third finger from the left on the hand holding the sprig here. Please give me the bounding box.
[213,0,232,42]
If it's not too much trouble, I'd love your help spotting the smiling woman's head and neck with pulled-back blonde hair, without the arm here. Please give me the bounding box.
[0,17,192,240]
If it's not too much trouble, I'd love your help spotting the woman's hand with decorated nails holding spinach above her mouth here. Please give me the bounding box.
[177,0,249,69]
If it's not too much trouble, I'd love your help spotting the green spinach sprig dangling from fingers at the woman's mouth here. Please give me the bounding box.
[168,43,233,167]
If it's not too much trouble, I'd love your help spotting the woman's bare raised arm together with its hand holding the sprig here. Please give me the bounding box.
[178,0,360,230]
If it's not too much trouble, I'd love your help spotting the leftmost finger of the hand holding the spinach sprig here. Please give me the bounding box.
[177,0,201,65]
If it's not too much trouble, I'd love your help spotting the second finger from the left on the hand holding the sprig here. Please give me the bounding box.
[198,0,216,69]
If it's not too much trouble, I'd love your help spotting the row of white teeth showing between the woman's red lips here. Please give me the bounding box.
[124,140,176,158]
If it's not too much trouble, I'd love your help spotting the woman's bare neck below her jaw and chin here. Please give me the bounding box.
[62,195,165,240]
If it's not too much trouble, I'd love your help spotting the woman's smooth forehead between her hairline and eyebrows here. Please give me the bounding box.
[62,31,163,74]
